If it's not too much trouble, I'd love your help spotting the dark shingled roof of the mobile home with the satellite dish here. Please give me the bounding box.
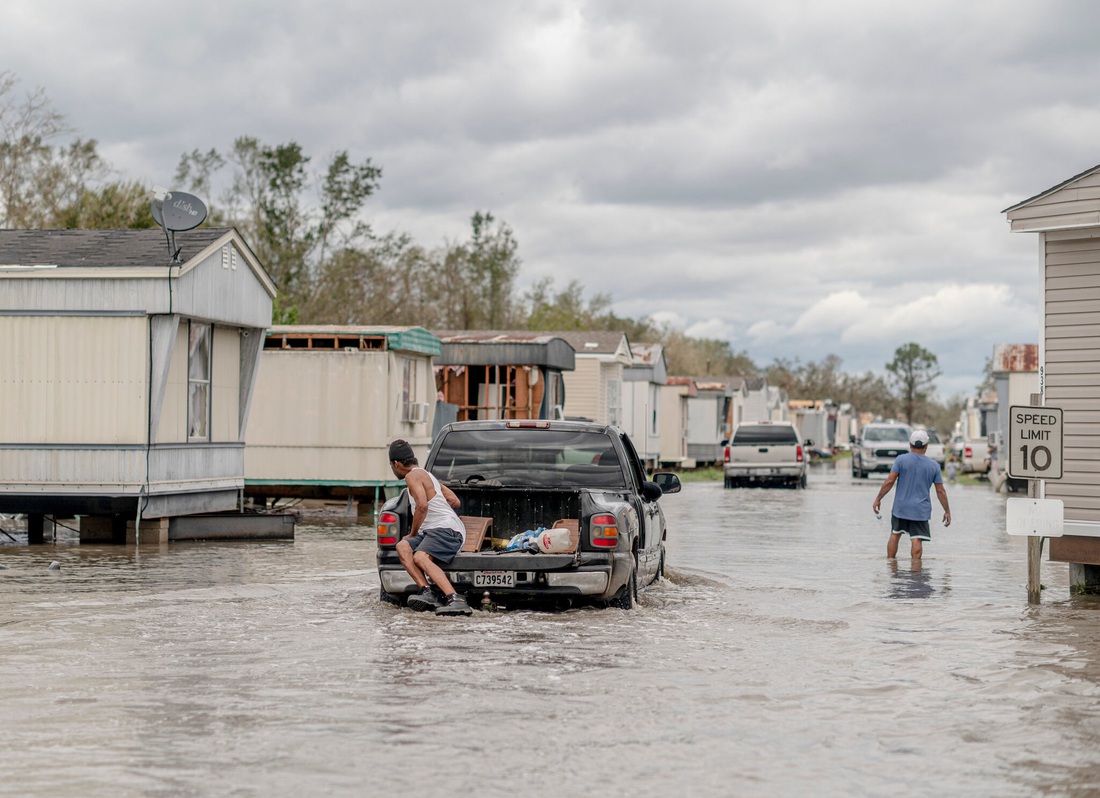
[0,227,232,267]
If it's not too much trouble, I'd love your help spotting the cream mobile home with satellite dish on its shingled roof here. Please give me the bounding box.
[0,228,275,539]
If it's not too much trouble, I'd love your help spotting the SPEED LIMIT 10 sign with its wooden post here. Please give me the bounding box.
[1005,393,1063,604]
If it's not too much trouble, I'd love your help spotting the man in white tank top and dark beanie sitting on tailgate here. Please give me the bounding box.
[389,439,472,615]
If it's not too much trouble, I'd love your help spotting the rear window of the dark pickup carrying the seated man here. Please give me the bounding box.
[429,428,627,488]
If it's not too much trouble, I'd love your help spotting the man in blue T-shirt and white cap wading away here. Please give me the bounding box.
[871,429,952,560]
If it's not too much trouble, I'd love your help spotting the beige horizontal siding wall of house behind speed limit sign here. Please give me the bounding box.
[1044,238,1100,522]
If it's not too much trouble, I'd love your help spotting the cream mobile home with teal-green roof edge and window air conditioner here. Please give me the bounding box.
[244,325,439,502]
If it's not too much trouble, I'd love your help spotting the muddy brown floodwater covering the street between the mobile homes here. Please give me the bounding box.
[0,463,1100,797]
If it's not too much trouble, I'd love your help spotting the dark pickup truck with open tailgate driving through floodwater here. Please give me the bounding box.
[377,420,680,609]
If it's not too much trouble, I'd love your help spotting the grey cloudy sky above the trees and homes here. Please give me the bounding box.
[0,0,1100,397]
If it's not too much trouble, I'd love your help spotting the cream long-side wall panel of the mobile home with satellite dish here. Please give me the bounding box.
[0,316,149,444]
